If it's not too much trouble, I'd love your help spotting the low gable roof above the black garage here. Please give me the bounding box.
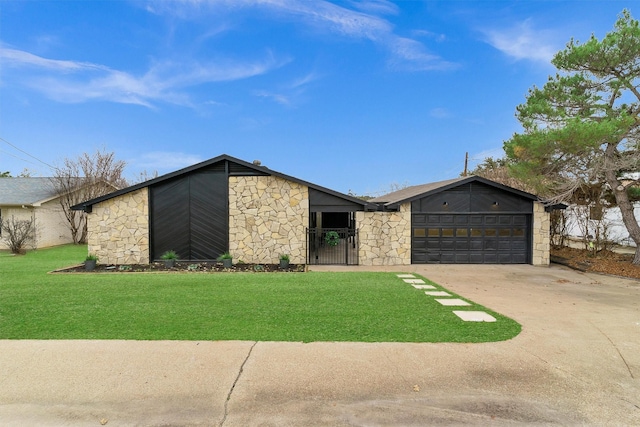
[369,175,539,208]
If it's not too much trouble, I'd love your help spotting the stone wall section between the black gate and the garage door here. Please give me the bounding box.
[356,203,411,265]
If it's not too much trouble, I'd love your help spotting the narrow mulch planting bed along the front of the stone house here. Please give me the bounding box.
[54,262,306,273]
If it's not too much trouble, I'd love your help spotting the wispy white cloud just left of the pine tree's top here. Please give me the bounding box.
[482,20,558,63]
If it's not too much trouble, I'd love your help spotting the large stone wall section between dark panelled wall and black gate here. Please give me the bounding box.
[229,176,309,264]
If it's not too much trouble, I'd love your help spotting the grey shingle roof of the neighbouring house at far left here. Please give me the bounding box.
[0,178,57,206]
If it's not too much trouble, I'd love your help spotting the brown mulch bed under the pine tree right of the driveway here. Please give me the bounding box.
[551,247,640,279]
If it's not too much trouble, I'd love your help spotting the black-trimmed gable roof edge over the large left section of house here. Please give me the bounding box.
[71,154,375,212]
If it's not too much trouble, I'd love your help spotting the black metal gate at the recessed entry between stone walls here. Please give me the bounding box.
[307,228,358,265]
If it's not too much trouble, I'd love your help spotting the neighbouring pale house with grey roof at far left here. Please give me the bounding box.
[0,177,73,249]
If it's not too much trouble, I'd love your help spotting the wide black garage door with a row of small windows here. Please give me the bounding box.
[411,214,531,264]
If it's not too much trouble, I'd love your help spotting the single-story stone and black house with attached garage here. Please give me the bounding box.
[73,155,549,265]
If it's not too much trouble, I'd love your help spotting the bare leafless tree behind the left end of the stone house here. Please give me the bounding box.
[51,150,127,243]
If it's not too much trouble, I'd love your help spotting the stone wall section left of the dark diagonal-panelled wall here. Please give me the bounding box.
[87,187,149,264]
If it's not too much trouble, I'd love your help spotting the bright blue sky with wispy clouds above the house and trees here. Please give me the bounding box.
[0,0,640,194]
